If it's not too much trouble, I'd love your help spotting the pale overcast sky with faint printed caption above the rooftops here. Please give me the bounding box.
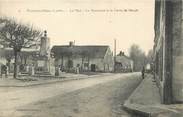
[0,0,154,53]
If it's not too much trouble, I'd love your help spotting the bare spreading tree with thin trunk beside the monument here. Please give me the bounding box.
[0,18,41,78]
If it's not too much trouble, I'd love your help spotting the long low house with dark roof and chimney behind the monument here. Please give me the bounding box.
[51,42,114,72]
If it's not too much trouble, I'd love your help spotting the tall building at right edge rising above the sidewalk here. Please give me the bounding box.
[154,0,183,104]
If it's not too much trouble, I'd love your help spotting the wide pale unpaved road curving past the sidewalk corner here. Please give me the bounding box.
[0,73,141,117]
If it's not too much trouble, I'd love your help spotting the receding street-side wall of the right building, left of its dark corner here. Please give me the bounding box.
[154,0,165,101]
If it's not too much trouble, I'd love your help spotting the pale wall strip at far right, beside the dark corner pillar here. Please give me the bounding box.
[172,0,183,102]
